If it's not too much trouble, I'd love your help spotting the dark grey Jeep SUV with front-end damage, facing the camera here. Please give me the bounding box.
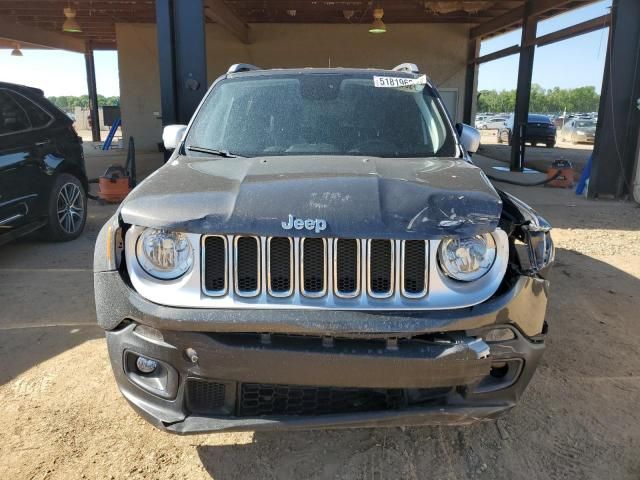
[95,64,554,433]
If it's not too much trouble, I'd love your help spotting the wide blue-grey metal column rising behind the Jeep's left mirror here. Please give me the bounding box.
[156,0,207,126]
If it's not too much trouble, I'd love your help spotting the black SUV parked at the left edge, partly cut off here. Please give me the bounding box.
[0,82,87,244]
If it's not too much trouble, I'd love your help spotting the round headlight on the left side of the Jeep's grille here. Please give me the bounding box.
[136,228,193,280]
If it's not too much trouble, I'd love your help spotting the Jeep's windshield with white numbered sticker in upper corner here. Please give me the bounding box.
[185,73,457,158]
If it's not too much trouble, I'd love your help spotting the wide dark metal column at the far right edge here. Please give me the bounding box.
[588,0,640,198]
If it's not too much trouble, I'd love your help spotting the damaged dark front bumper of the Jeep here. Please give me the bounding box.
[95,272,547,434]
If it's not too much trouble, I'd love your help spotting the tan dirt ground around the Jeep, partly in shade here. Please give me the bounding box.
[0,164,640,480]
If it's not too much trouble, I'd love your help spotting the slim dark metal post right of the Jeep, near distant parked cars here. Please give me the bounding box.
[510,7,538,172]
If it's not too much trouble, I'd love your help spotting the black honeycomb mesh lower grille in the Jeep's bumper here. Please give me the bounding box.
[238,383,405,417]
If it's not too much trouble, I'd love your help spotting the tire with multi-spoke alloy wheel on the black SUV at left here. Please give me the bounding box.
[44,173,87,242]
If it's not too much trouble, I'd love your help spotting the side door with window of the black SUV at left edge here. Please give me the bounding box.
[0,89,52,234]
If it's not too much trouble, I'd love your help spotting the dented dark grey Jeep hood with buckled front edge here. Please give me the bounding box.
[120,156,502,239]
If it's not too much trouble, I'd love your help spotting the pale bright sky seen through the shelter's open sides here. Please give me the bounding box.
[0,0,611,97]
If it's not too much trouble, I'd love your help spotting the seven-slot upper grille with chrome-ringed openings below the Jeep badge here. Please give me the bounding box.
[202,235,429,306]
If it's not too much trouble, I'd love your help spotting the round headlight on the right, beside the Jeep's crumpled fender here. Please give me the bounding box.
[438,233,496,282]
